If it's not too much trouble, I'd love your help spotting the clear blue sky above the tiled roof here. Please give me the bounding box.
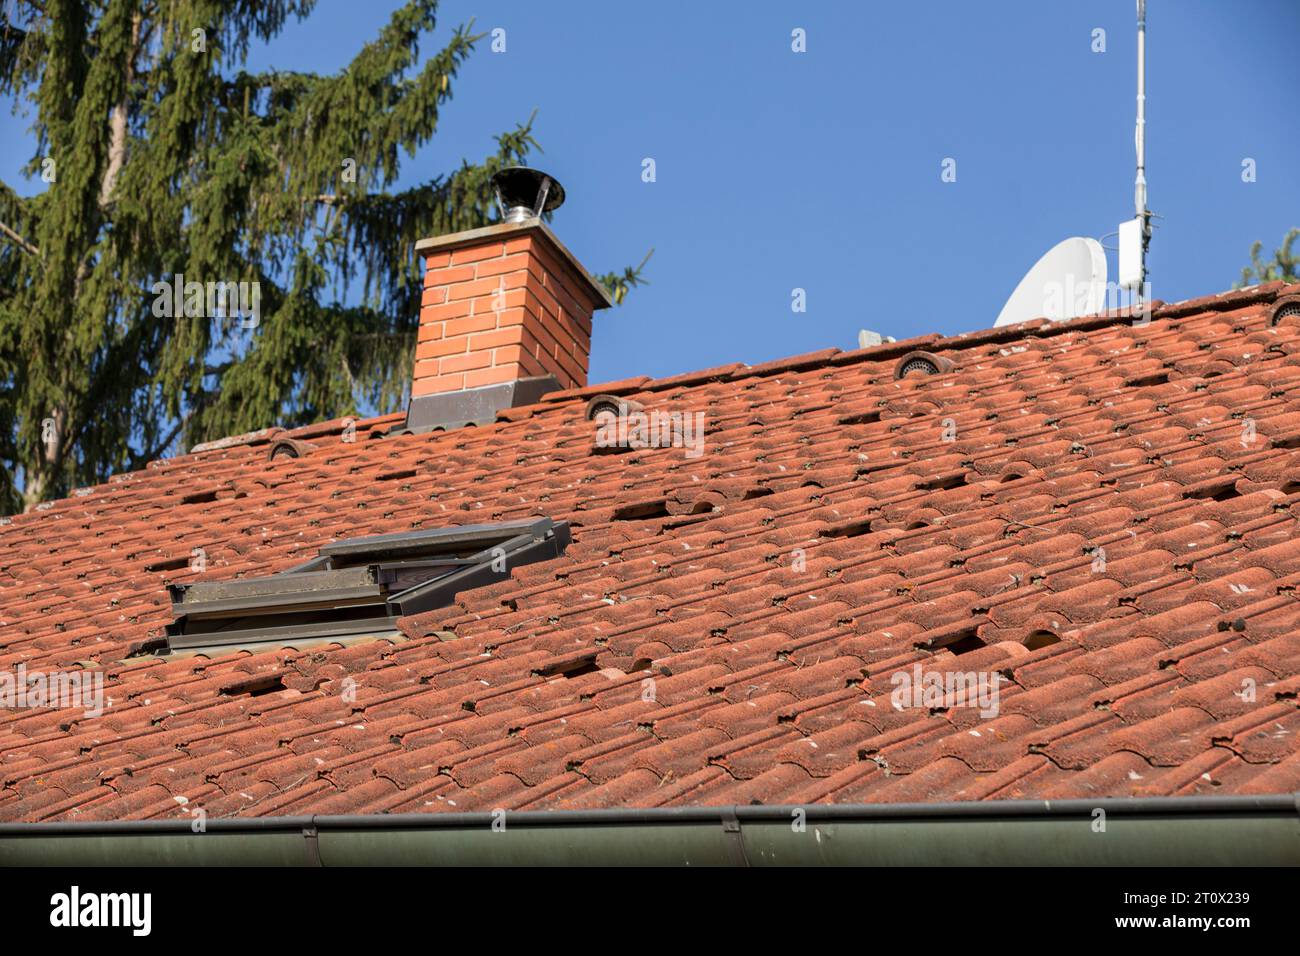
[0,0,1300,381]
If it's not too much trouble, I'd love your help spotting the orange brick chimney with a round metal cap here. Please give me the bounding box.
[407,168,612,432]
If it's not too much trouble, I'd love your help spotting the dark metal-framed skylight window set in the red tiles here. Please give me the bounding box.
[166,518,571,652]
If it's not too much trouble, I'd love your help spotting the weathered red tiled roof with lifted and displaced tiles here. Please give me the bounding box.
[0,284,1300,821]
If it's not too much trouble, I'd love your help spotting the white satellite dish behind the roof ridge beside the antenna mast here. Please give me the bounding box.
[993,237,1106,326]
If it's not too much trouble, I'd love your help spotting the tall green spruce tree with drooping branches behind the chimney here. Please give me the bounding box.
[0,0,640,511]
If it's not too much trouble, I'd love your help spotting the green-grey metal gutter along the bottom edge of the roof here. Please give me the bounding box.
[0,795,1300,866]
